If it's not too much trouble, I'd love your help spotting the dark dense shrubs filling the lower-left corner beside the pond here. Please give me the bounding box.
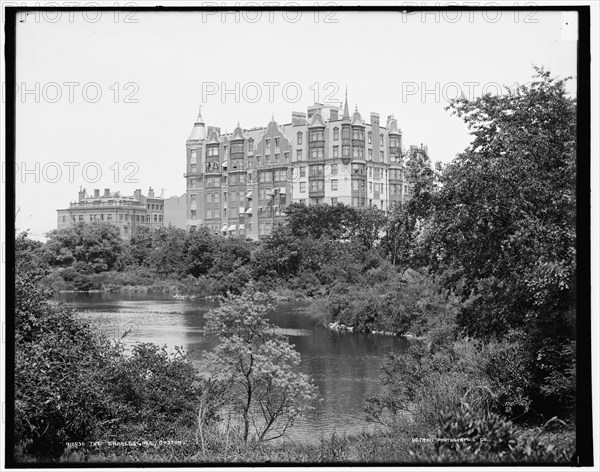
[15,232,213,460]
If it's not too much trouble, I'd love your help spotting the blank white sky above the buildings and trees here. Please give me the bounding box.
[9,11,577,238]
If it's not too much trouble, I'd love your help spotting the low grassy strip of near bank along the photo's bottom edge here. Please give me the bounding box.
[49,425,575,465]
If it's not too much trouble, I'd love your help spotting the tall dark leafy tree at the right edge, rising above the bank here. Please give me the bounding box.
[424,69,576,410]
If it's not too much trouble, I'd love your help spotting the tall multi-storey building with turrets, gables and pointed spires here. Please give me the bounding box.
[184,94,429,239]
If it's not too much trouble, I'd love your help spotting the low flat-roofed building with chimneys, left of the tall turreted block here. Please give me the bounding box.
[57,188,173,239]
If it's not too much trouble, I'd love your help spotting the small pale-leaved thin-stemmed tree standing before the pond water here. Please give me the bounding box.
[204,291,317,442]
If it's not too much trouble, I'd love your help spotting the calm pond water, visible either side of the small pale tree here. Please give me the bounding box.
[57,293,408,441]
